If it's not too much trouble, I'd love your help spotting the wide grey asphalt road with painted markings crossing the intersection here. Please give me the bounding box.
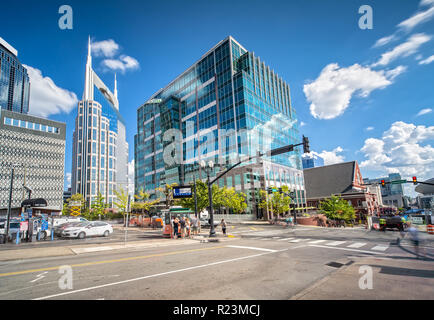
[0,225,434,300]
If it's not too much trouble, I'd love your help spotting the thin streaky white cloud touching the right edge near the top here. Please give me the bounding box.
[372,33,434,67]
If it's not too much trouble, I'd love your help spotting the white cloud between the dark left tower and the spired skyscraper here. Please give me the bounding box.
[23,65,78,117]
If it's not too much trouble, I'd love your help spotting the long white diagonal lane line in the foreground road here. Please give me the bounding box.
[32,249,287,300]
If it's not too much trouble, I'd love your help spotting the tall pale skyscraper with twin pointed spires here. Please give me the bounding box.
[71,39,128,207]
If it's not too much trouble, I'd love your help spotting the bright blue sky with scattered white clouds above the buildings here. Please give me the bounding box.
[0,0,434,195]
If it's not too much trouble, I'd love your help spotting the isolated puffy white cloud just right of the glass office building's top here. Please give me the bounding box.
[303,63,406,119]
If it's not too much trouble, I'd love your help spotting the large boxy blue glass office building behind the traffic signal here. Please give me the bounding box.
[135,37,305,217]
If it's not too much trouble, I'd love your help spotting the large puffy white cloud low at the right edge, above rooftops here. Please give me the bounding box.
[360,121,434,180]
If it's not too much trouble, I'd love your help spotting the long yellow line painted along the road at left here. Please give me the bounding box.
[0,246,225,277]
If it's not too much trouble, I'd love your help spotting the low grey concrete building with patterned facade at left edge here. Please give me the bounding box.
[0,109,66,215]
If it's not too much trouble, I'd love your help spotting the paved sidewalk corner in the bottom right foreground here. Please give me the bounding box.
[290,257,434,300]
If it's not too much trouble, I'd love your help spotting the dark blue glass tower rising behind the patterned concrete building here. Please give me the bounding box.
[0,38,30,114]
